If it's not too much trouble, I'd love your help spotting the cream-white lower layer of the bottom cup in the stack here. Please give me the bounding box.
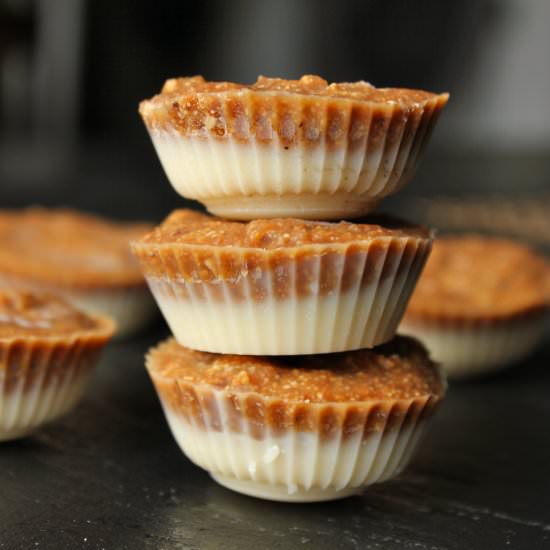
[163,406,426,502]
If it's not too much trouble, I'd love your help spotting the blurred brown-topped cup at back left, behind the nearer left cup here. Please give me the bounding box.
[0,208,156,336]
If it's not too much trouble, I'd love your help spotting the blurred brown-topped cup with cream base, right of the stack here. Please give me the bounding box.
[399,235,550,378]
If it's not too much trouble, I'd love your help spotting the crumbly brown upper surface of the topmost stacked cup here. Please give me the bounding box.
[146,75,444,109]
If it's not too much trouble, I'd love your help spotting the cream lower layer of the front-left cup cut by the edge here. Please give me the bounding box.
[0,371,90,441]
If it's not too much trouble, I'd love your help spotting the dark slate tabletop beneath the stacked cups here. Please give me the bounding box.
[0,326,550,550]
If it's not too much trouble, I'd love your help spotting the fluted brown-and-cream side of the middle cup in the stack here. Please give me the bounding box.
[140,238,430,355]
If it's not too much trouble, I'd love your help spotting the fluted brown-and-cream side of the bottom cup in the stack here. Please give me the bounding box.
[151,384,444,501]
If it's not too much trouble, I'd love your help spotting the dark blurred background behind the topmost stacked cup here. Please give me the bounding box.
[0,0,550,244]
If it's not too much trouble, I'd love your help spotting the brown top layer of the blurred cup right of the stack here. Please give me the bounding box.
[406,235,550,321]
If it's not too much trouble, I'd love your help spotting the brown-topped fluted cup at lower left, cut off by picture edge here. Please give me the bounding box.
[0,290,115,441]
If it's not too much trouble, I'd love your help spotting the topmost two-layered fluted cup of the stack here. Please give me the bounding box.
[140,76,448,220]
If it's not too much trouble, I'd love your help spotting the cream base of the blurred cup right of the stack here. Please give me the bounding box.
[399,314,545,378]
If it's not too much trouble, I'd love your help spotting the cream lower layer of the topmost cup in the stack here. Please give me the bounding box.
[150,130,422,220]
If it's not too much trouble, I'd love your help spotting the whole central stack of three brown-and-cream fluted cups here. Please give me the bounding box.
[132,76,448,502]
